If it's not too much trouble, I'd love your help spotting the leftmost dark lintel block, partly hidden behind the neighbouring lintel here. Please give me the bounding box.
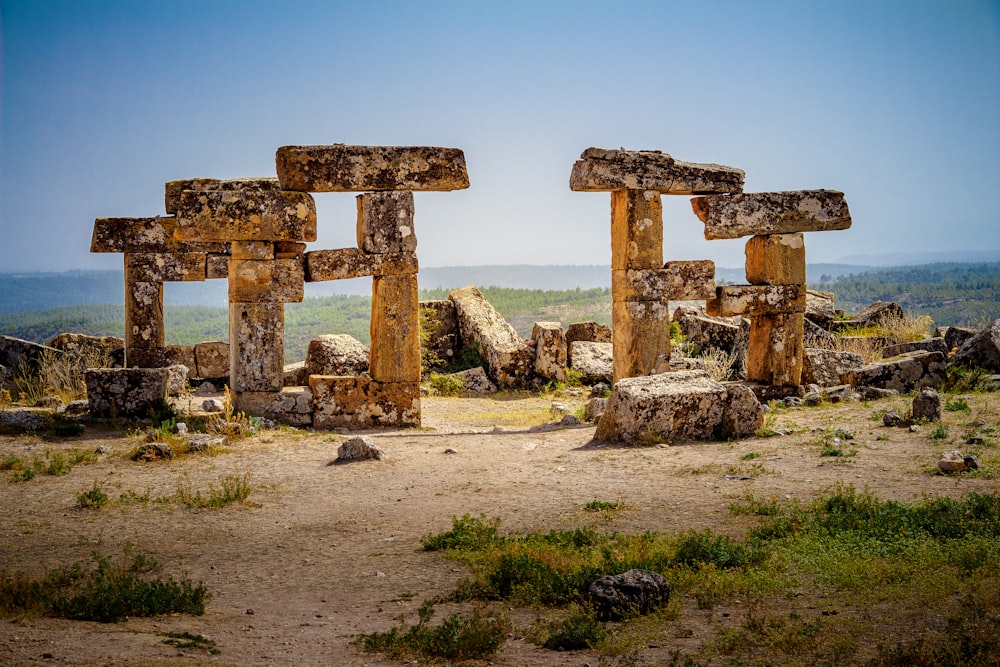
[90,216,228,253]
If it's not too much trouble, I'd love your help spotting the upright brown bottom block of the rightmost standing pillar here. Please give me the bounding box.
[747,313,804,386]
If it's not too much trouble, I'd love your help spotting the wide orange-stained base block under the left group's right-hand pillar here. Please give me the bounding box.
[309,375,420,429]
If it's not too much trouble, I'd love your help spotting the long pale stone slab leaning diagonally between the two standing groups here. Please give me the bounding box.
[448,286,535,389]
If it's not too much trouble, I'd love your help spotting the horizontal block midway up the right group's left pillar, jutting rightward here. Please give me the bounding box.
[611,260,715,301]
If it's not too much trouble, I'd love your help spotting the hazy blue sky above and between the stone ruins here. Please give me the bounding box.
[0,0,1000,271]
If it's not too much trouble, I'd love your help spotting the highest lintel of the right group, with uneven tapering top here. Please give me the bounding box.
[569,148,743,195]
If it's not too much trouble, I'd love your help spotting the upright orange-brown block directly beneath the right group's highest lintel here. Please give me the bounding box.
[611,190,663,270]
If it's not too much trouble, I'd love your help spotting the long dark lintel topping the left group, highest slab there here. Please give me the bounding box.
[275,144,469,192]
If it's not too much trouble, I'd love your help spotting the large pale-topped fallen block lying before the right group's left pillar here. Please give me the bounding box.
[594,371,726,444]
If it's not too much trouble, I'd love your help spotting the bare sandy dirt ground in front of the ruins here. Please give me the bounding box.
[0,394,1000,666]
